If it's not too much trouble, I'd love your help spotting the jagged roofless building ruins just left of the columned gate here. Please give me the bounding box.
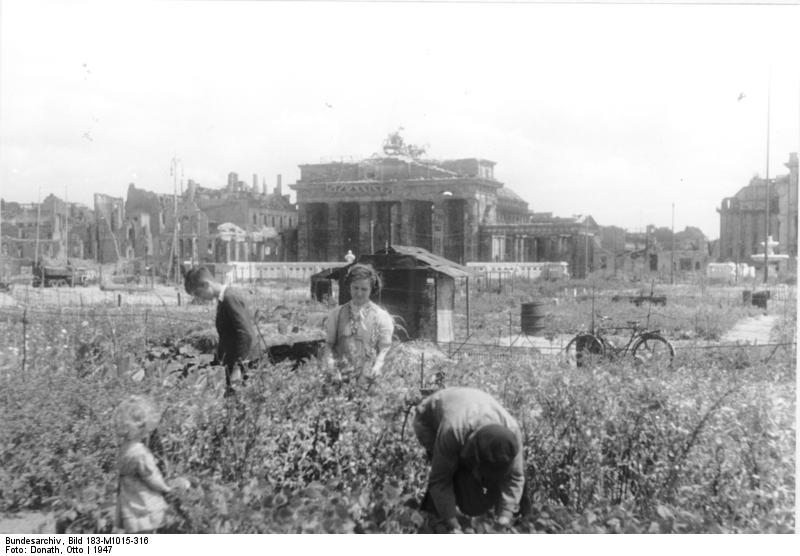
[94,172,297,274]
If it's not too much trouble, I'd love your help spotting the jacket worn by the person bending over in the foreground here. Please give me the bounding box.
[414,388,525,520]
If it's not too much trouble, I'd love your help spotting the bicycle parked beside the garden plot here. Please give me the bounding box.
[564,317,675,367]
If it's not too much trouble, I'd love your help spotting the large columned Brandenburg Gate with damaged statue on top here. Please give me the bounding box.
[291,133,597,276]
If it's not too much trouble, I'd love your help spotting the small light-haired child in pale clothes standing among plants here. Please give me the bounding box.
[114,396,179,533]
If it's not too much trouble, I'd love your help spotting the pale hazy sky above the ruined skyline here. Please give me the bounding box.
[0,0,800,238]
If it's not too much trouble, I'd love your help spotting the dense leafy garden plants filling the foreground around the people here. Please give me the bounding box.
[0,282,796,533]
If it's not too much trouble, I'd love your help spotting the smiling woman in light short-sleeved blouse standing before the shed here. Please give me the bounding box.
[325,264,394,378]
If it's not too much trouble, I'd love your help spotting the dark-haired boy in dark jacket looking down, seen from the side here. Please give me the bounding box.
[184,266,261,396]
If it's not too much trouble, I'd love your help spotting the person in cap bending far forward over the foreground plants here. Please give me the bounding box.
[414,387,527,533]
